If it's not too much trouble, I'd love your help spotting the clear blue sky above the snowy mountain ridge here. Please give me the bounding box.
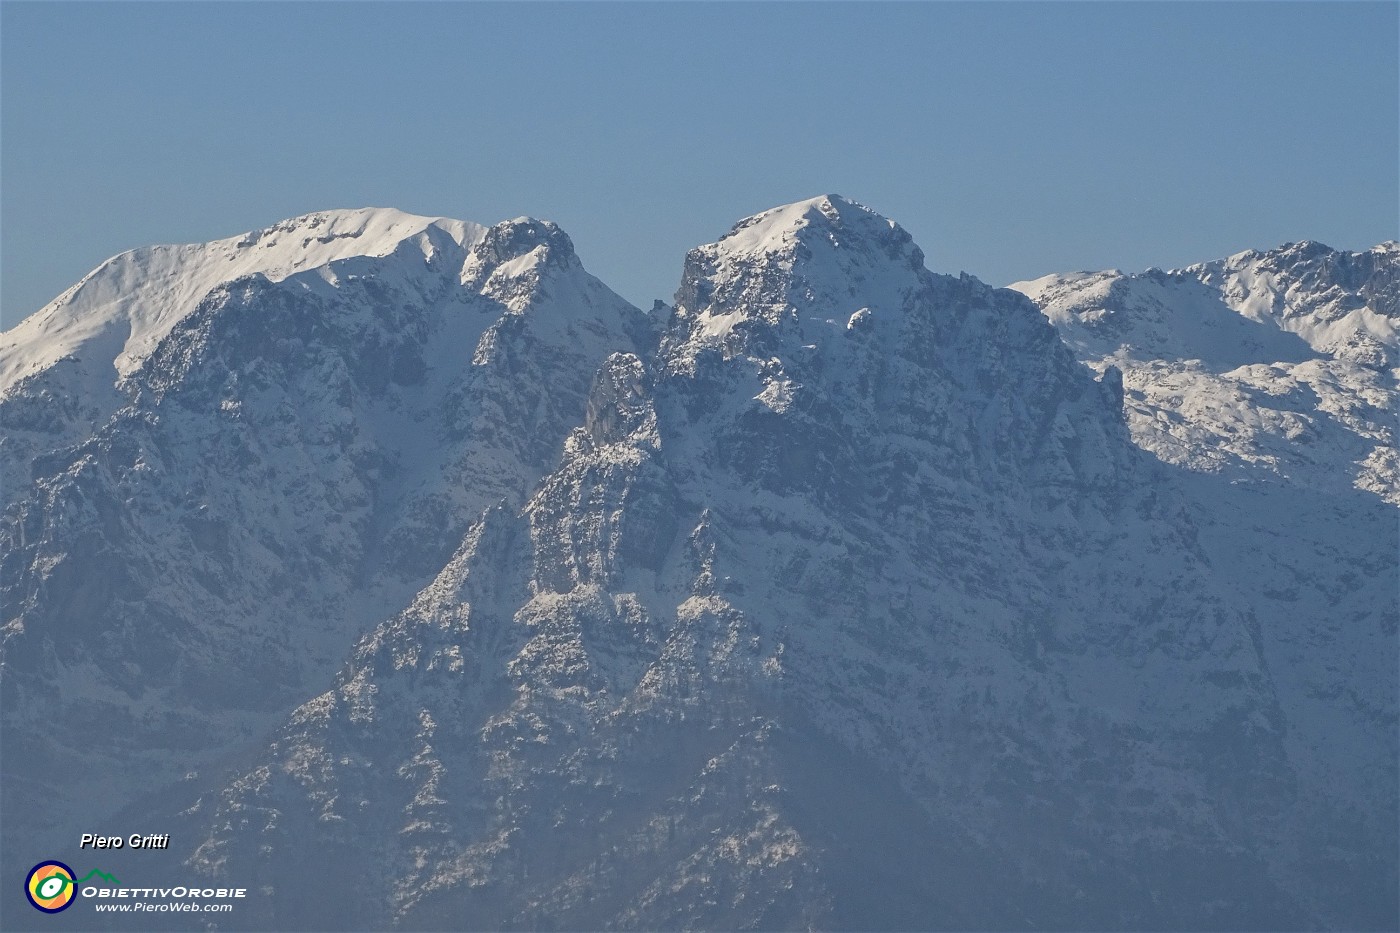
[0,0,1400,326]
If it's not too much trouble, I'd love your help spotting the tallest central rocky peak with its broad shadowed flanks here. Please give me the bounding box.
[87,196,1394,929]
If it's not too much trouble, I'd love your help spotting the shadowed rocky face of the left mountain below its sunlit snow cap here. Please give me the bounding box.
[0,212,647,879]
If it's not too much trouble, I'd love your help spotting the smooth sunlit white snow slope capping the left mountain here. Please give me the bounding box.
[0,207,484,502]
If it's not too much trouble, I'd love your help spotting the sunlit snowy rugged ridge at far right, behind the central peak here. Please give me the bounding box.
[1011,241,1400,504]
